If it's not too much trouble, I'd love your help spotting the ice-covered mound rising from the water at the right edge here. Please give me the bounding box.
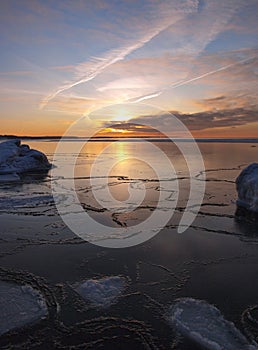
[236,163,258,213]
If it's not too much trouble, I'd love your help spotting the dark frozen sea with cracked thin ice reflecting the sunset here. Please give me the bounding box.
[0,140,258,350]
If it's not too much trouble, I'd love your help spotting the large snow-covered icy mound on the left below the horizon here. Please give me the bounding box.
[0,139,51,182]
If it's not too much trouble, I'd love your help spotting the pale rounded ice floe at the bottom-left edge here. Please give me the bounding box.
[0,281,48,335]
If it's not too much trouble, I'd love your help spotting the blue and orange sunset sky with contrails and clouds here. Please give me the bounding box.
[0,0,258,137]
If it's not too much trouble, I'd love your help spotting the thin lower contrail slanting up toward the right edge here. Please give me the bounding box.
[129,56,256,103]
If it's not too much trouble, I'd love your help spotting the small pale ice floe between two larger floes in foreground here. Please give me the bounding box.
[75,276,126,307]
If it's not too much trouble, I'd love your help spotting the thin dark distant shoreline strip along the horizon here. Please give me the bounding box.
[0,135,258,143]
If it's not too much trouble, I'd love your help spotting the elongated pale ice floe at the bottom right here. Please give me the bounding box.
[169,298,256,350]
